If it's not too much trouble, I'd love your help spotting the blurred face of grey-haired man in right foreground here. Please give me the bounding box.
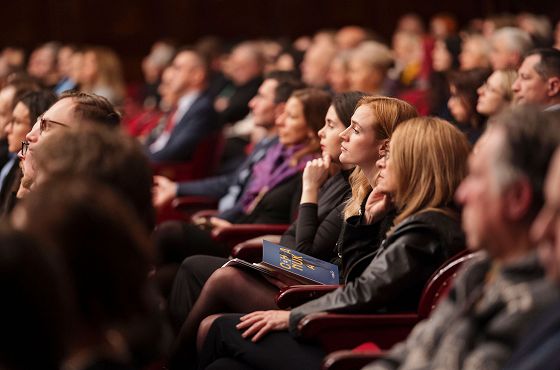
[455,130,506,252]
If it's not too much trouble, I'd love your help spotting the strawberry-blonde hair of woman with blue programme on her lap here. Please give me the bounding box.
[344,96,418,218]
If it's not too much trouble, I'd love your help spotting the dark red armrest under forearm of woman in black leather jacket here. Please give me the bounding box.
[299,313,420,352]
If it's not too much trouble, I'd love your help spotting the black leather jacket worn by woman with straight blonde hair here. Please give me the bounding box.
[290,211,465,335]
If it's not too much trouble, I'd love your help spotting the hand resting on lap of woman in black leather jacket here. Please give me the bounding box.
[236,310,290,342]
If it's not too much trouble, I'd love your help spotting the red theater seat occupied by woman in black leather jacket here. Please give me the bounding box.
[277,253,478,352]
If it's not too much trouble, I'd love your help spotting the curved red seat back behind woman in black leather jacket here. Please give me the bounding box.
[418,251,480,320]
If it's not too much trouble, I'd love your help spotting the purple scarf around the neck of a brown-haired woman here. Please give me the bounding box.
[241,143,317,214]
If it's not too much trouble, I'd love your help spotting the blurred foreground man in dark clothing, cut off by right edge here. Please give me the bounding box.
[506,150,560,370]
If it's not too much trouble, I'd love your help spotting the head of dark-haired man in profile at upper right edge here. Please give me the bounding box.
[512,48,560,111]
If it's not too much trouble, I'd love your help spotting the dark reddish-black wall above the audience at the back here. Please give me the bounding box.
[0,0,560,79]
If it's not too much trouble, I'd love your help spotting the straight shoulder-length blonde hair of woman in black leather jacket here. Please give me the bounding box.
[390,117,470,225]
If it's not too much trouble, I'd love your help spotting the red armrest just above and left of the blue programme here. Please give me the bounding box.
[212,224,290,250]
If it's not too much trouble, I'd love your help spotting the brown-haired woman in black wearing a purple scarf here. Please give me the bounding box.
[154,89,331,266]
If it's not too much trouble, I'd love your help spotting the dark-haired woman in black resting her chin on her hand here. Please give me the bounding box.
[169,92,364,329]
